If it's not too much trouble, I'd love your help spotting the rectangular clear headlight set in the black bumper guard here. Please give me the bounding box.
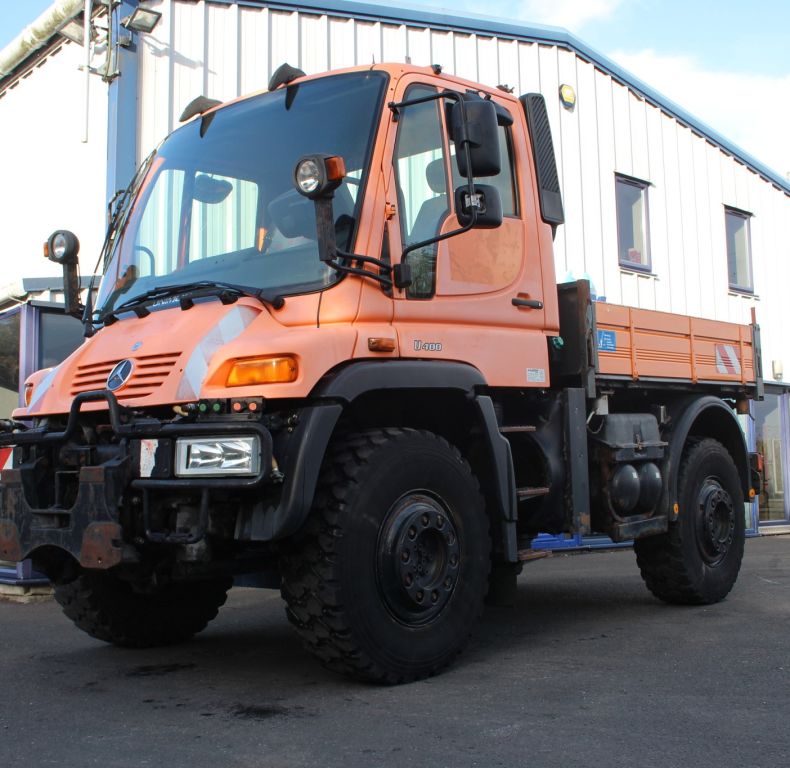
[176,435,261,477]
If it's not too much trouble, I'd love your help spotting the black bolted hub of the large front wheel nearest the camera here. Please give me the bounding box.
[376,493,461,625]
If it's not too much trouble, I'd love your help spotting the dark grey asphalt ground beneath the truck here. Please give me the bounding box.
[0,536,790,768]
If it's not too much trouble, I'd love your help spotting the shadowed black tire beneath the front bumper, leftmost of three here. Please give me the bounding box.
[55,571,233,648]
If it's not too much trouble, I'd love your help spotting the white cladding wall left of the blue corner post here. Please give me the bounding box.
[0,42,107,287]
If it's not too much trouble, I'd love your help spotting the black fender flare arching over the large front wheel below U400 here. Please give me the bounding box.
[250,360,517,562]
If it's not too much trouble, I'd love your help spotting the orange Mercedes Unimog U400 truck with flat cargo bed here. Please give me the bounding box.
[0,65,762,682]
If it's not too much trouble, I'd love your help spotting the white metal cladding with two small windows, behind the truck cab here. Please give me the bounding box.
[139,0,790,372]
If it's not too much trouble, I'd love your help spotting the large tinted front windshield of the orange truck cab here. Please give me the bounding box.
[96,72,387,315]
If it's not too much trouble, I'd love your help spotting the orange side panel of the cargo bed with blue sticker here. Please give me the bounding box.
[595,302,755,384]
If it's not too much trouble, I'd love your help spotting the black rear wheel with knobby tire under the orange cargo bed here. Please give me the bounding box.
[634,438,746,605]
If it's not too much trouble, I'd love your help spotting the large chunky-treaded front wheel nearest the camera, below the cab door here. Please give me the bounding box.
[282,429,491,684]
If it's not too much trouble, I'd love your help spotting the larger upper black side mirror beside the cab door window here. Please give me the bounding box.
[450,99,501,178]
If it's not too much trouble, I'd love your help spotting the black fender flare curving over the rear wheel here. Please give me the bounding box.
[662,395,751,521]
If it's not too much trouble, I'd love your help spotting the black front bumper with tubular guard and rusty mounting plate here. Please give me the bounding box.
[0,391,273,568]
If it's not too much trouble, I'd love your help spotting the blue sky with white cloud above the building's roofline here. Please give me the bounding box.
[0,0,790,176]
